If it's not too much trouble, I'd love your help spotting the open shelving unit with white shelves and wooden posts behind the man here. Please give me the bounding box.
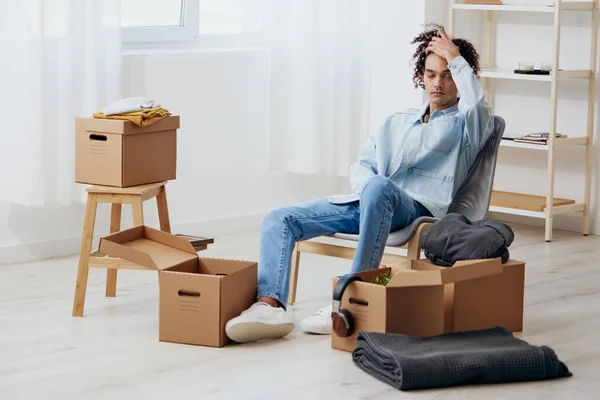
[447,0,600,242]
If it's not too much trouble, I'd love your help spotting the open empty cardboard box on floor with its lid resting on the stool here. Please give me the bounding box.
[100,226,258,347]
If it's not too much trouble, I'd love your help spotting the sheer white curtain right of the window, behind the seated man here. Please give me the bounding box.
[268,0,371,176]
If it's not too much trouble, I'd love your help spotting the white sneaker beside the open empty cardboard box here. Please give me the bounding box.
[225,302,294,343]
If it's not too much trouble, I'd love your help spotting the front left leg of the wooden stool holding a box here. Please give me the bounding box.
[73,193,98,317]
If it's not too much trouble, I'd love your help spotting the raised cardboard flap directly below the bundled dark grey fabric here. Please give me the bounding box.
[411,258,502,284]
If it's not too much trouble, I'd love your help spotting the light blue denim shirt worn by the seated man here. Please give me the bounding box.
[328,56,494,218]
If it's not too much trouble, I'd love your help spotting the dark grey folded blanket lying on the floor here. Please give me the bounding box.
[352,327,572,390]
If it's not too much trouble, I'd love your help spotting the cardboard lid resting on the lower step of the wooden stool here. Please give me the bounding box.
[100,226,198,270]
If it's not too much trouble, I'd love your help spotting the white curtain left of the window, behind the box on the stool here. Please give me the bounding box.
[0,0,122,205]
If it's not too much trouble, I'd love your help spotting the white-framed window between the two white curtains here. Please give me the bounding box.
[121,0,266,43]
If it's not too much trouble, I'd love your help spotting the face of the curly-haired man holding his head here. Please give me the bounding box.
[423,53,458,110]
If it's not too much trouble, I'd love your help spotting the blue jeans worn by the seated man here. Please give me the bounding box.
[257,175,431,307]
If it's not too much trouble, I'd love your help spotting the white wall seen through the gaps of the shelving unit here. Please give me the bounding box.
[426,0,600,232]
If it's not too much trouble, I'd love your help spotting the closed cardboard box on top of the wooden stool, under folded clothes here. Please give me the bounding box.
[75,116,179,187]
